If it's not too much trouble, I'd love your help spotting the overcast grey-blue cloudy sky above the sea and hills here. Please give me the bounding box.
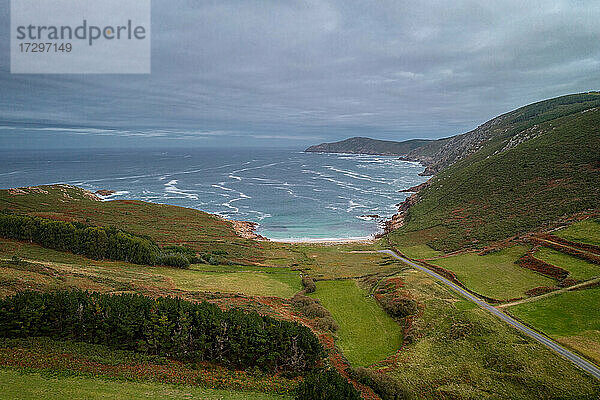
[0,0,600,147]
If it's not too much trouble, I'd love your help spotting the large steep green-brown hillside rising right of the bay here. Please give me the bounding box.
[389,95,600,251]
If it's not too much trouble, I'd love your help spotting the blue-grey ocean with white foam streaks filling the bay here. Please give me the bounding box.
[0,148,427,240]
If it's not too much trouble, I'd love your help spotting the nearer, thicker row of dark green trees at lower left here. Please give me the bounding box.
[0,290,324,373]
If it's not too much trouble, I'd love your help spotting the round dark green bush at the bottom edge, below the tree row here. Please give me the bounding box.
[296,370,361,400]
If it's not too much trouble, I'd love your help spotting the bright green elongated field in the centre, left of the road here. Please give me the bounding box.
[312,280,402,366]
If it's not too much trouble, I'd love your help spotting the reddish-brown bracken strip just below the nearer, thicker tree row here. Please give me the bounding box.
[0,338,297,398]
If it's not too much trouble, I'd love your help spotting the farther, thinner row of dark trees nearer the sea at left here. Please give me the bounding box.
[0,213,190,268]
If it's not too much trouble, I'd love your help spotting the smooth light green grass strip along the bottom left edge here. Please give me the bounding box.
[0,369,292,400]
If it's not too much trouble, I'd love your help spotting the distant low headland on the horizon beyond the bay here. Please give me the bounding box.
[305,137,437,156]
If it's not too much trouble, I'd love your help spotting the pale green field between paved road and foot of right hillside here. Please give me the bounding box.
[432,246,556,300]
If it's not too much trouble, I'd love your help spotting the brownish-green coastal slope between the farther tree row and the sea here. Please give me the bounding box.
[0,185,262,262]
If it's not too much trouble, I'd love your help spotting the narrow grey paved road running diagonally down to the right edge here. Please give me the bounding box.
[380,250,600,379]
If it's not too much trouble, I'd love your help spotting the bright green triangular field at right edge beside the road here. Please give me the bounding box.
[509,288,600,362]
